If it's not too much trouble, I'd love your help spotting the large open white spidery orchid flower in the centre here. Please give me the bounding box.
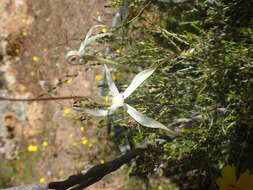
[75,65,178,135]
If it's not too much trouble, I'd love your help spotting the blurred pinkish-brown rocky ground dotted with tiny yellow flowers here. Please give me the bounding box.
[0,0,142,190]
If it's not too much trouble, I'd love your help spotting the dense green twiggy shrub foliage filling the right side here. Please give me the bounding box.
[104,0,253,189]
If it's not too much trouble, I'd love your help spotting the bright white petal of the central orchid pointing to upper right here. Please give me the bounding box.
[123,68,156,98]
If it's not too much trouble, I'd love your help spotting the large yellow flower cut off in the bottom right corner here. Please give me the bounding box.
[216,165,253,190]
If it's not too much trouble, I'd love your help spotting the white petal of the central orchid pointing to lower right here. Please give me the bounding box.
[125,104,178,135]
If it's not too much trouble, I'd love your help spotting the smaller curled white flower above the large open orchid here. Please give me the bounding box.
[65,25,112,63]
